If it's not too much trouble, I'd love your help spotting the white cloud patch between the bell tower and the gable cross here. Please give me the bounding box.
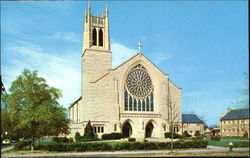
[111,42,137,68]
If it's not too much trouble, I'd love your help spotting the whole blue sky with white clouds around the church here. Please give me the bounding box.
[1,1,249,125]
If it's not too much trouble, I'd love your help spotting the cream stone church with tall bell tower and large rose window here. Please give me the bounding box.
[69,4,182,138]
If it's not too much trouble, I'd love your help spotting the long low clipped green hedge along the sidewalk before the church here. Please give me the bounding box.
[35,140,207,152]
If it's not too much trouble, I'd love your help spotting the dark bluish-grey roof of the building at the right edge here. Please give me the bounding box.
[220,109,249,120]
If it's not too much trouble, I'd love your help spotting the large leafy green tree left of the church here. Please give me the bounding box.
[3,69,69,150]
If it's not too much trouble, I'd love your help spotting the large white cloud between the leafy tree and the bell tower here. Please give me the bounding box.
[3,41,81,107]
